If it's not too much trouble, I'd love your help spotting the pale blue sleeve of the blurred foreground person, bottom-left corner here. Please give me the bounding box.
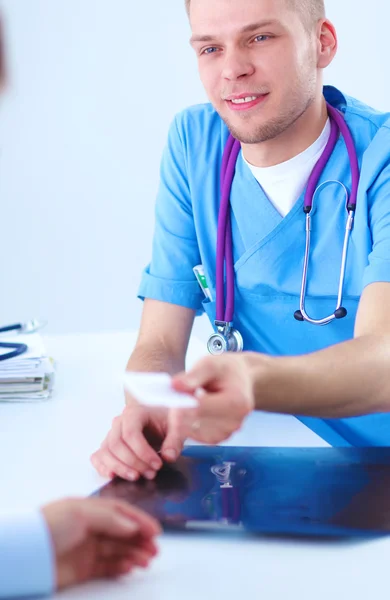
[0,511,55,598]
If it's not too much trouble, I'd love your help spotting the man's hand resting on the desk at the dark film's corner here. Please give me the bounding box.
[91,393,185,481]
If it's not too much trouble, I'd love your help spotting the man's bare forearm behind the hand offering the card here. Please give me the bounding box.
[248,335,390,418]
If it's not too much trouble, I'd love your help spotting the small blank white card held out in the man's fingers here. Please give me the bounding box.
[124,371,198,408]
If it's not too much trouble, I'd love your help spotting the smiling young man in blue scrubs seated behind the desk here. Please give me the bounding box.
[92,0,390,480]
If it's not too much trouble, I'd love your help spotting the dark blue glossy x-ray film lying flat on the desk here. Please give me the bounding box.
[96,446,390,536]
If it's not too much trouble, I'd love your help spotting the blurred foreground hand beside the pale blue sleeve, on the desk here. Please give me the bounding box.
[41,498,160,589]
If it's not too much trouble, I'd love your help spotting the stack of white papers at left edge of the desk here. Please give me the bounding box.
[0,333,54,401]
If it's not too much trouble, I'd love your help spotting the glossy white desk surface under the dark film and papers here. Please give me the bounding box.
[0,333,390,600]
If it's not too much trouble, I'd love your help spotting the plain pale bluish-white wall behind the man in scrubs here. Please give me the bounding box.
[0,0,390,333]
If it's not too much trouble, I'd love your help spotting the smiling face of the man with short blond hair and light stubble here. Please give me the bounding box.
[190,0,322,144]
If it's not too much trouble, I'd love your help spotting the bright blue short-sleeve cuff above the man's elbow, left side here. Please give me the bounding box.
[138,268,204,314]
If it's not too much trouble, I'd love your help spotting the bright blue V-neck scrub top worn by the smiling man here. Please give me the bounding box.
[139,86,390,446]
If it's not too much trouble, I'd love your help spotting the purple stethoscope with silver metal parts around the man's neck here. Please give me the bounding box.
[207,104,360,355]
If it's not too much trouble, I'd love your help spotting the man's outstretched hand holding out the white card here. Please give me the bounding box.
[169,353,255,444]
